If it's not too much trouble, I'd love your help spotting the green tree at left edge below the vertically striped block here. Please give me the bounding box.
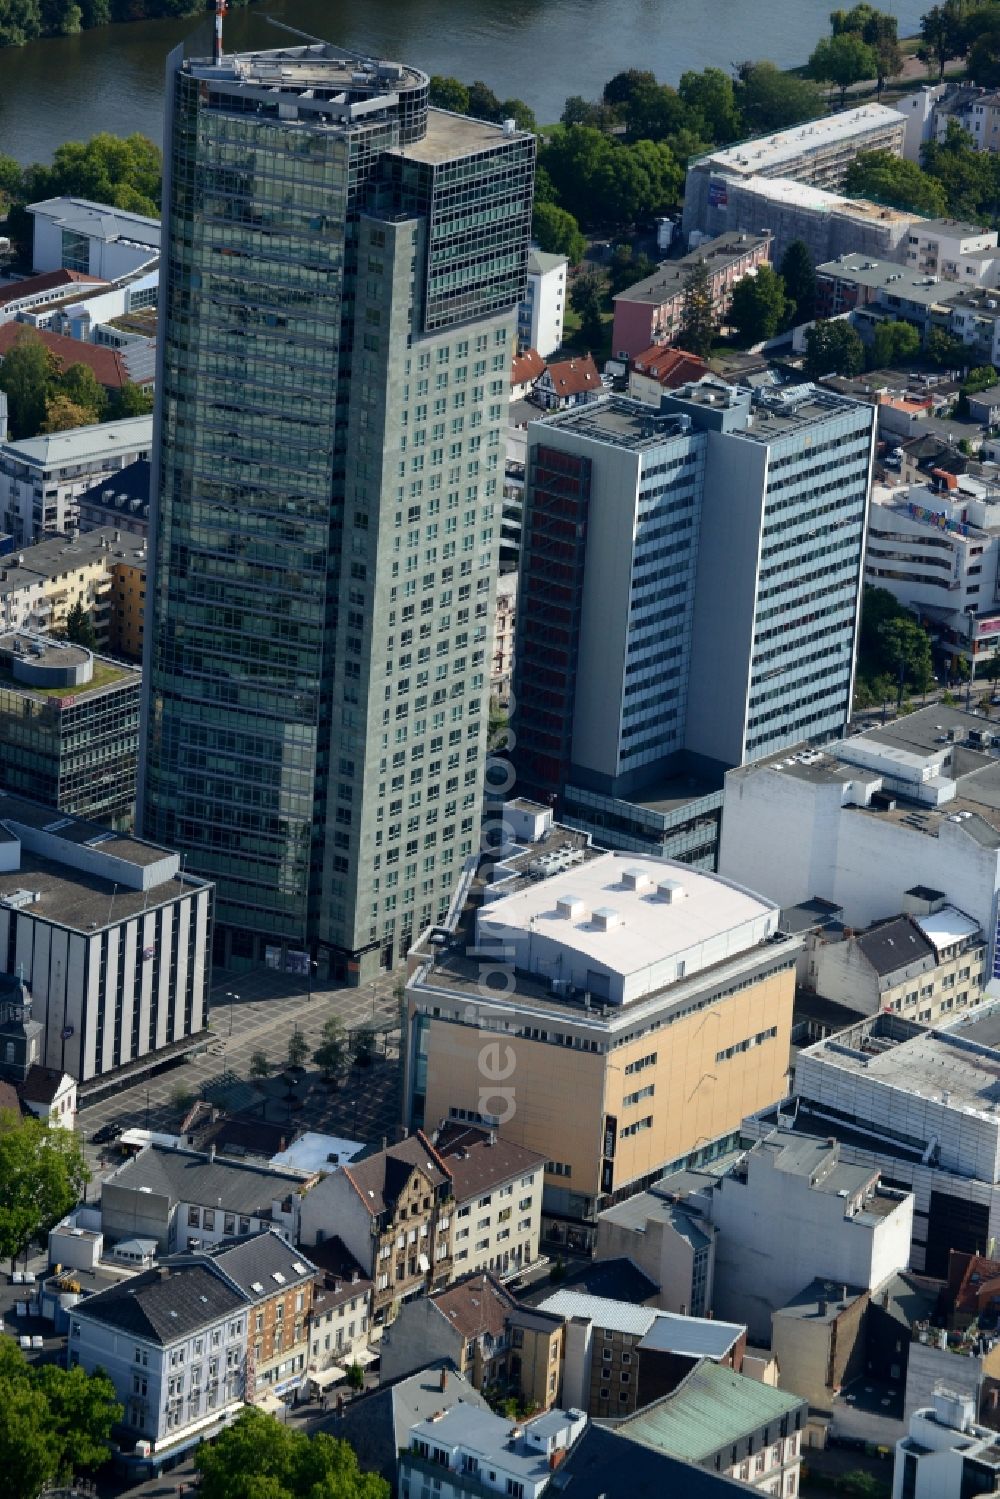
[0,1109,90,1267]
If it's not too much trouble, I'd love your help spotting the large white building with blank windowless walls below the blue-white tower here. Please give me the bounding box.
[720,706,1000,947]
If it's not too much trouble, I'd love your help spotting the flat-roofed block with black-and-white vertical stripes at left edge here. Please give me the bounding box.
[0,791,211,1082]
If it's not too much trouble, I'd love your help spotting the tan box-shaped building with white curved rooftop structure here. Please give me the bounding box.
[403,833,798,1247]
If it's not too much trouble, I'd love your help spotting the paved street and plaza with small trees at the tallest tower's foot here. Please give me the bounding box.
[78,968,402,1199]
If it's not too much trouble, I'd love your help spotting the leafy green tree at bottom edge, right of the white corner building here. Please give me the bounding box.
[195,1406,390,1499]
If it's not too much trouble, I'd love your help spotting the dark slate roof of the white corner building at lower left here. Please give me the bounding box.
[75,1265,246,1346]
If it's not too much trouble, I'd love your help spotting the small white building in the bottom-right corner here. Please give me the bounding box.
[892,1390,1000,1499]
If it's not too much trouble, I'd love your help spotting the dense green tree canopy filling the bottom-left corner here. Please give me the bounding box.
[0,1337,123,1499]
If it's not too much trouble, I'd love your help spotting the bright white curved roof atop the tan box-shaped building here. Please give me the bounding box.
[478,853,778,974]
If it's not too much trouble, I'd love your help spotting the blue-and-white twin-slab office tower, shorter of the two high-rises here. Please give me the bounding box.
[513,379,874,868]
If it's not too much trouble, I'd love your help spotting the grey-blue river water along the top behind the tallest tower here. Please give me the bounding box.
[0,0,928,162]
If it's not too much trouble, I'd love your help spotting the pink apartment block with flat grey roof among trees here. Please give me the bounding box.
[612,231,771,360]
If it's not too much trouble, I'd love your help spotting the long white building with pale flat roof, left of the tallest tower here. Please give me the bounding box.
[0,417,153,546]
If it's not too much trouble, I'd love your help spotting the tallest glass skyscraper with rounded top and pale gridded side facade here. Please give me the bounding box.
[141,43,534,982]
